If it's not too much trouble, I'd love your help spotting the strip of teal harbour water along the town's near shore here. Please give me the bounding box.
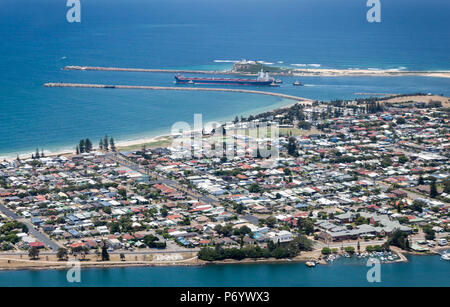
[0,256,450,287]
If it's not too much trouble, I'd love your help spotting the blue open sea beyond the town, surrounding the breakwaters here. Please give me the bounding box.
[0,0,450,156]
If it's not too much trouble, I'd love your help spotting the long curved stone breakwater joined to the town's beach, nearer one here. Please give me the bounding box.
[44,83,314,104]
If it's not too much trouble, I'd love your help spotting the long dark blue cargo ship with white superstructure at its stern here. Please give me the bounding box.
[175,71,277,86]
